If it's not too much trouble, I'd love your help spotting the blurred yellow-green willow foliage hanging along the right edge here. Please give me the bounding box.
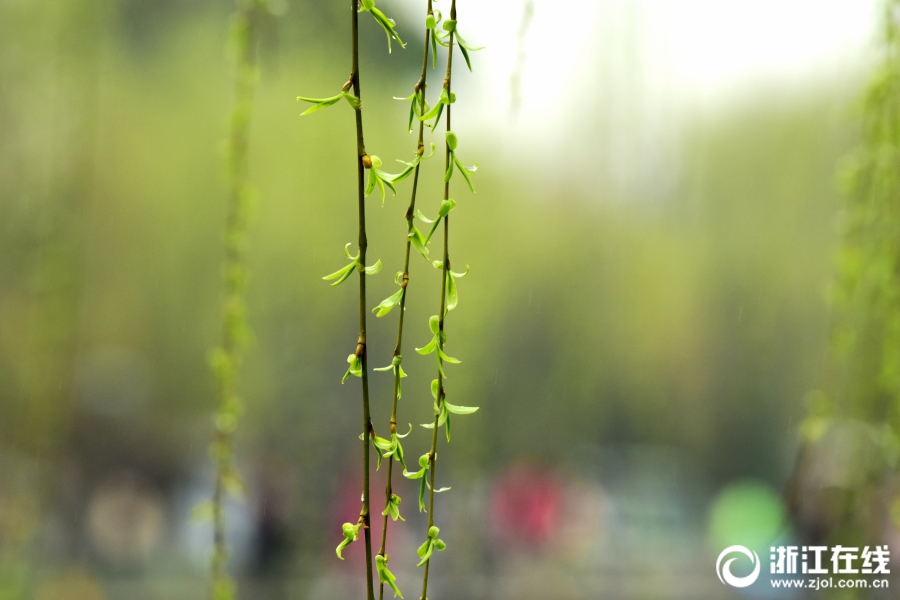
[792,0,900,545]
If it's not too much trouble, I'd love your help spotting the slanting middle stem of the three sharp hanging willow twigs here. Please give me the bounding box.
[378,0,433,600]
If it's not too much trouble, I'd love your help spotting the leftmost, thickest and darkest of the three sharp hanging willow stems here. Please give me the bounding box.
[349,0,375,600]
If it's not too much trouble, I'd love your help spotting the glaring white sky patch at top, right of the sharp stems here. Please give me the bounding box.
[435,0,878,130]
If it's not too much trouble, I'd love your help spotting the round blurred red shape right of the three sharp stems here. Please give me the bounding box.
[488,463,563,550]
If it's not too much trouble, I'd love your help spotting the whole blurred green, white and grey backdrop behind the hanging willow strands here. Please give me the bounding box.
[0,0,900,600]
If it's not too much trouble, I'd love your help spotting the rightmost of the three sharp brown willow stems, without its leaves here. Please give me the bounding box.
[420,0,456,600]
